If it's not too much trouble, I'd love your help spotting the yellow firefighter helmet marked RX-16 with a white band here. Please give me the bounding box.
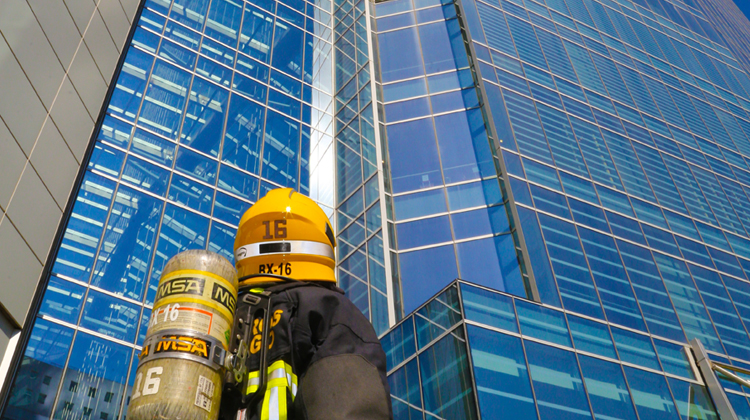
[234,188,336,287]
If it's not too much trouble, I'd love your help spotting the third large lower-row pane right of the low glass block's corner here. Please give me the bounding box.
[579,355,637,419]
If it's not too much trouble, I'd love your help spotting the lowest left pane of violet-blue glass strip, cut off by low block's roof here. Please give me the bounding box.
[399,245,458,313]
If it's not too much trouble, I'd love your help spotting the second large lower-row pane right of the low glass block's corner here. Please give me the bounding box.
[524,341,591,420]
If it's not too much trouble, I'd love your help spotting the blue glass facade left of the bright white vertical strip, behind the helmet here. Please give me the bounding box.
[3,0,334,420]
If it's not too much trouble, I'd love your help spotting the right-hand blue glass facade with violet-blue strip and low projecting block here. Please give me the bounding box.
[376,0,750,419]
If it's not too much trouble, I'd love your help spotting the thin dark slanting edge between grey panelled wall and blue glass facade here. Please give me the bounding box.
[0,0,151,417]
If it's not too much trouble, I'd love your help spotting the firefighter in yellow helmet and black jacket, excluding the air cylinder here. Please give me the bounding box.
[220,188,392,420]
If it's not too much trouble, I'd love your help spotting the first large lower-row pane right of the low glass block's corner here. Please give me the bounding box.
[467,325,538,419]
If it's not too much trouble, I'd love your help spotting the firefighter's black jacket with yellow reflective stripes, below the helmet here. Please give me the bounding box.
[222,282,393,420]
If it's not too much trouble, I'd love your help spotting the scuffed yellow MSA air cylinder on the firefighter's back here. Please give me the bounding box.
[127,250,237,420]
